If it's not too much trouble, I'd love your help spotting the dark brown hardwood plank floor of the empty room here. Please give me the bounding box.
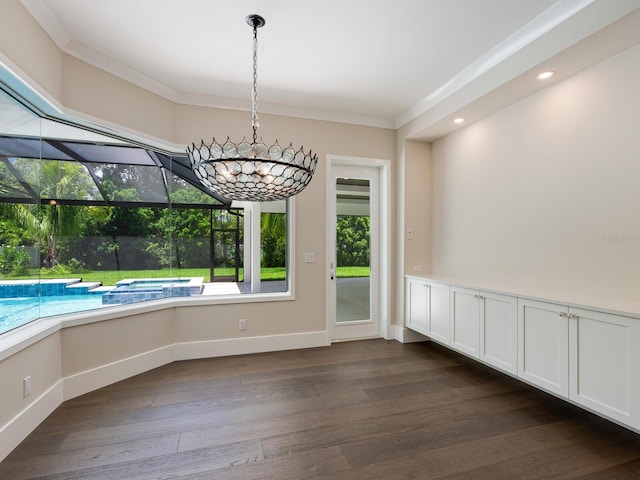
[0,340,640,480]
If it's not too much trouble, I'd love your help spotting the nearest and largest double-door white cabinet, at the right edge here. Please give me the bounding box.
[518,300,640,428]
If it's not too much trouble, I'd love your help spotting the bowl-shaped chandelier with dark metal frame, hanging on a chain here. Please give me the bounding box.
[187,15,318,202]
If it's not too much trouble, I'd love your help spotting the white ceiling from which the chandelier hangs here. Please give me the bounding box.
[17,0,640,139]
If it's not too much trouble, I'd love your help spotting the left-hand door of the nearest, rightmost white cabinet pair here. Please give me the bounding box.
[518,299,569,397]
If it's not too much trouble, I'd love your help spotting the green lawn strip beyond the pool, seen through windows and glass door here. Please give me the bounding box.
[12,267,369,285]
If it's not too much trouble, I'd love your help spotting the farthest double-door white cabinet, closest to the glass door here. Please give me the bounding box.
[405,277,449,344]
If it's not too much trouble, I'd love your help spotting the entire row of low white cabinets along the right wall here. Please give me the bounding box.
[406,277,640,431]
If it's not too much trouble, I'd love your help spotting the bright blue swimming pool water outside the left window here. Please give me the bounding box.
[0,294,103,333]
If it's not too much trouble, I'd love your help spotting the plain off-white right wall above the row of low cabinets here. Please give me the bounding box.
[432,46,640,299]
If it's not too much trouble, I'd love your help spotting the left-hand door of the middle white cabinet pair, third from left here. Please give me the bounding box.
[451,287,480,358]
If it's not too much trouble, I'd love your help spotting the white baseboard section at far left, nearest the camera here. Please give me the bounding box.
[0,380,63,461]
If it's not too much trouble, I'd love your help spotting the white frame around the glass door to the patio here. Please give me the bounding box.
[325,155,391,344]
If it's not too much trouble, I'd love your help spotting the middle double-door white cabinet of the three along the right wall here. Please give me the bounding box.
[451,287,518,374]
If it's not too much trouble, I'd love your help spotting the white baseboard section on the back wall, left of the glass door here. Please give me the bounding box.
[175,331,327,360]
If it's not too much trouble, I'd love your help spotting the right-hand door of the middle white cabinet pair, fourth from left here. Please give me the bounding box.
[479,292,518,375]
